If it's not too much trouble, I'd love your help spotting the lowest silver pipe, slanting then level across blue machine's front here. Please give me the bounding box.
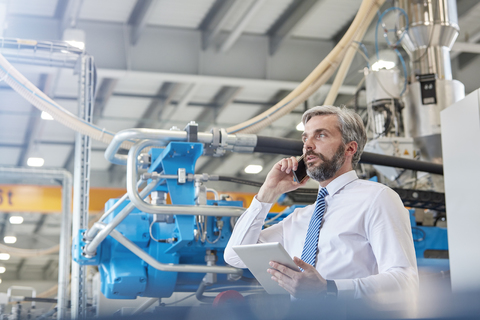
[110,230,243,275]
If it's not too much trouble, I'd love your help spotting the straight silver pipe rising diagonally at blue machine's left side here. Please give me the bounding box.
[84,180,160,256]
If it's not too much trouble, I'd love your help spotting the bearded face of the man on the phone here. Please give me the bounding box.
[302,115,345,182]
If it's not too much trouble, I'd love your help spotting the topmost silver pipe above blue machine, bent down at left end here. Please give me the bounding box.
[105,129,213,165]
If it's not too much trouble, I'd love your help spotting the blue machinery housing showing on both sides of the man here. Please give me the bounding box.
[73,142,449,299]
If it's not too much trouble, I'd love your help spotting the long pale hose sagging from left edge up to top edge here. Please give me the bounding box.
[0,0,385,149]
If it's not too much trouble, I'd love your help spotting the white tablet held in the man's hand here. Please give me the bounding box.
[232,242,300,294]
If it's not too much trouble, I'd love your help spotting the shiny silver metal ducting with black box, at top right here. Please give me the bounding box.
[395,0,465,163]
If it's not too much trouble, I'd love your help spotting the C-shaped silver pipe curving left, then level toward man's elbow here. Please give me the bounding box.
[127,140,245,217]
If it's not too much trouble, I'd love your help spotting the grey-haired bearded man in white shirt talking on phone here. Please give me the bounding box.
[225,106,418,304]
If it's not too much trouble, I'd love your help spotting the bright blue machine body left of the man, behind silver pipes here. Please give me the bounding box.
[73,142,251,299]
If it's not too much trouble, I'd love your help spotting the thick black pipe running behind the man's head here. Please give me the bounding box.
[253,136,443,175]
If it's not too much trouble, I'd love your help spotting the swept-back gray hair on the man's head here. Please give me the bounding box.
[302,106,367,168]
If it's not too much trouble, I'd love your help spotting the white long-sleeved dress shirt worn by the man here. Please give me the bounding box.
[225,170,418,304]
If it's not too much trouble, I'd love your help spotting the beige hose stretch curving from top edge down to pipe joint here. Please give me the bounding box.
[227,0,385,133]
